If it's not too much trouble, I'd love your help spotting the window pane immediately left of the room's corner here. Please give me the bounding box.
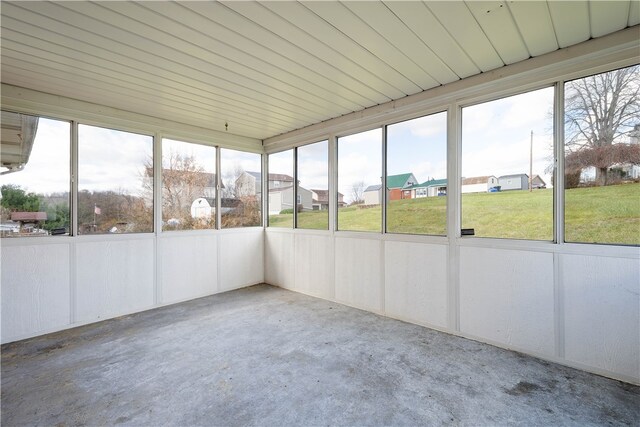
[220,148,262,228]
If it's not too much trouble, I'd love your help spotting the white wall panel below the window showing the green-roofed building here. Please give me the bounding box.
[384,241,448,328]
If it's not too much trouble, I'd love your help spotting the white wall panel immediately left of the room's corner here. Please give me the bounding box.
[218,228,264,291]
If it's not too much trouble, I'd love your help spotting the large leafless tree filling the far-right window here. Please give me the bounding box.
[565,66,640,185]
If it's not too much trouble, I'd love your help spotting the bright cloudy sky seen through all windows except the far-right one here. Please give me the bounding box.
[0,87,553,201]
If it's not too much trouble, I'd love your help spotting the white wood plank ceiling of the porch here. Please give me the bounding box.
[0,1,640,139]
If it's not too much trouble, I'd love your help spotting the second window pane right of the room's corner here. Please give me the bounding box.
[297,141,330,230]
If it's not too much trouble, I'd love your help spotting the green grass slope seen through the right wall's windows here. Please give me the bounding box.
[269,183,640,245]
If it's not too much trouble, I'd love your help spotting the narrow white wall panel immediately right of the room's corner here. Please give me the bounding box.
[265,229,295,289]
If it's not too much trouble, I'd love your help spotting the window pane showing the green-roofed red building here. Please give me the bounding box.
[387,112,447,235]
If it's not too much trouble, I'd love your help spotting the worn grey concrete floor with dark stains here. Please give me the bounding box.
[1,285,640,426]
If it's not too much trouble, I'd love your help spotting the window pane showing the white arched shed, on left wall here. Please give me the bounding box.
[161,139,216,231]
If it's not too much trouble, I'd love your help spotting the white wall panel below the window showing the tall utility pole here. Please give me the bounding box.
[460,247,555,357]
